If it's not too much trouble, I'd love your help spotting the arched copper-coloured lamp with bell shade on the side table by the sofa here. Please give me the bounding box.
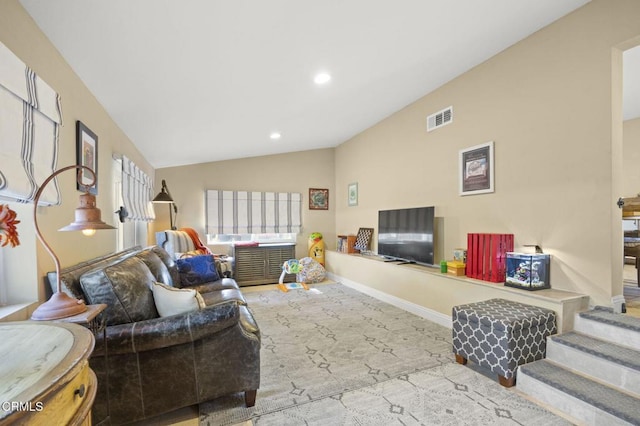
[31,165,116,321]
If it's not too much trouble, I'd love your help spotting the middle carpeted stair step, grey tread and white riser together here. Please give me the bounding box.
[547,331,640,397]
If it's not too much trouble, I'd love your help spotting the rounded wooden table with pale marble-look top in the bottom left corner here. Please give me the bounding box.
[0,321,97,426]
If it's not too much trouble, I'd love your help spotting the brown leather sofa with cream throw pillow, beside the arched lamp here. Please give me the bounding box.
[48,246,260,424]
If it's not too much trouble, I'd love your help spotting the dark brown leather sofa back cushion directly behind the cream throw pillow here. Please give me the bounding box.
[80,257,158,325]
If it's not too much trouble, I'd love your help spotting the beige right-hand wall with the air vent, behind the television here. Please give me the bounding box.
[336,0,640,304]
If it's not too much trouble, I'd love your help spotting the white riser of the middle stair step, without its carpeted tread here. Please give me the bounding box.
[547,339,640,398]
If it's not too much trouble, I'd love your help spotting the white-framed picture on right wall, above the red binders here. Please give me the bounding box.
[458,141,495,195]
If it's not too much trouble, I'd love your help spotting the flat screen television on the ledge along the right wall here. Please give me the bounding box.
[378,207,435,265]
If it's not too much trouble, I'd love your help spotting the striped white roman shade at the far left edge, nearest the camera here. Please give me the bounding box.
[0,43,62,205]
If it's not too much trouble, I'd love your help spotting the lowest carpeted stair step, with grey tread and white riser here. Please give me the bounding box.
[517,359,640,425]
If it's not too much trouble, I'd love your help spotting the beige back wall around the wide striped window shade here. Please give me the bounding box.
[150,145,338,258]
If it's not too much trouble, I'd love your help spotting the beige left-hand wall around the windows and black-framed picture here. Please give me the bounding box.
[0,0,153,302]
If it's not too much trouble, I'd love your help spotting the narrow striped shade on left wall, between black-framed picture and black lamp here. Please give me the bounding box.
[122,155,156,221]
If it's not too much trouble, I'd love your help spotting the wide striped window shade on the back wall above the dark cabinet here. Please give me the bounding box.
[206,190,302,234]
